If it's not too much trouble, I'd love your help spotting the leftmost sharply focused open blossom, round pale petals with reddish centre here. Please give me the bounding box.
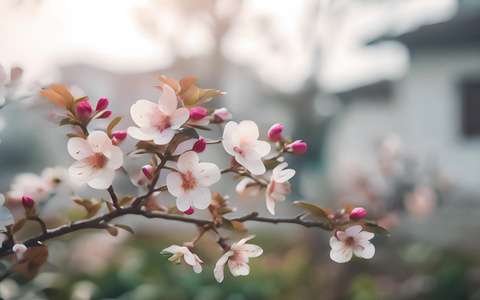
[67,131,123,189]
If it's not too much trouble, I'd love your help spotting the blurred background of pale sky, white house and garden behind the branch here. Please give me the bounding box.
[0,0,480,299]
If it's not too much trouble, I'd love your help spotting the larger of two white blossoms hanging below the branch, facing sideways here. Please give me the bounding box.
[213,235,263,282]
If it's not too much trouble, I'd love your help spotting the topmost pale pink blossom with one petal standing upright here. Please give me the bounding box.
[128,85,190,145]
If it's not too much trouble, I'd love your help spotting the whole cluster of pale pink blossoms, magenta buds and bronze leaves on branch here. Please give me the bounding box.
[0,76,381,282]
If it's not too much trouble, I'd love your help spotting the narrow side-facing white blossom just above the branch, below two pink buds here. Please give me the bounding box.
[266,162,295,215]
